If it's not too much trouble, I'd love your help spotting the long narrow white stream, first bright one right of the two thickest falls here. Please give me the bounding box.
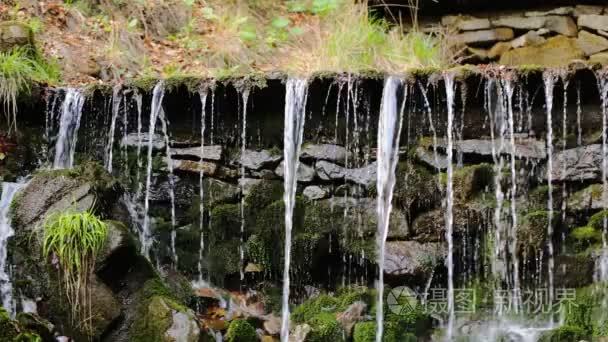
[444,73,454,342]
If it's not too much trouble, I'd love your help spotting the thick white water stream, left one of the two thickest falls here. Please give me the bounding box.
[281,78,308,342]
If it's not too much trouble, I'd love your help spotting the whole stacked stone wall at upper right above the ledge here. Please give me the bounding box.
[441,5,608,67]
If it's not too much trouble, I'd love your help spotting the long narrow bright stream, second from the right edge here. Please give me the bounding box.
[543,72,555,303]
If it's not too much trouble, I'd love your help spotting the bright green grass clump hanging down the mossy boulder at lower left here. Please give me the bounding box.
[42,212,108,332]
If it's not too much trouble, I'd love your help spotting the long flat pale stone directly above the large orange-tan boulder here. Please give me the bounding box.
[492,16,578,37]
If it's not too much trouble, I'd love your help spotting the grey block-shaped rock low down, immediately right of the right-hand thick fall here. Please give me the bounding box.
[384,241,445,276]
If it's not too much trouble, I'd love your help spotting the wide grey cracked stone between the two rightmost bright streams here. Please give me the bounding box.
[544,144,602,182]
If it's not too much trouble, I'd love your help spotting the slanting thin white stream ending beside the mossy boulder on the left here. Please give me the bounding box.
[140,81,165,259]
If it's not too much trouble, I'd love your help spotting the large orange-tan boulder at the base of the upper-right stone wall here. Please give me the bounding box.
[499,36,584,67]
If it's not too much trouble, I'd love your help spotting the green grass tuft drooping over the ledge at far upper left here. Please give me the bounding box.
[0,47,59,133]
